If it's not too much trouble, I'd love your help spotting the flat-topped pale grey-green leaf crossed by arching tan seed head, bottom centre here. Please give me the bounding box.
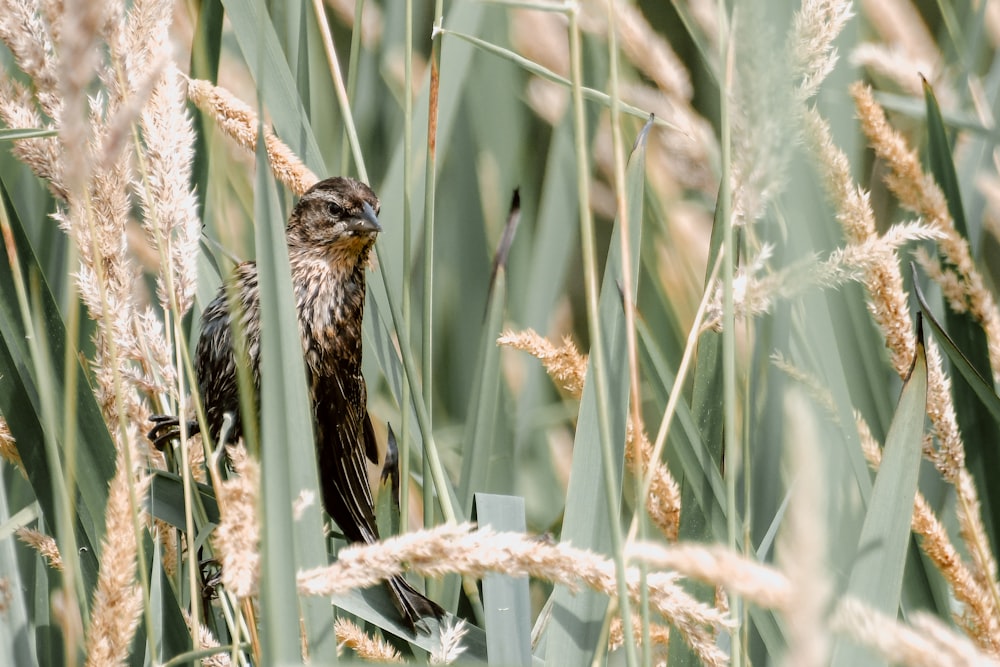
[473,493,531,667]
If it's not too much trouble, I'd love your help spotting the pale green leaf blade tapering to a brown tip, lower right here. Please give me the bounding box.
[833,320,927,666]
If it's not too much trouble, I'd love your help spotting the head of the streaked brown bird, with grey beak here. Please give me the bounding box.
[286,176,382,260]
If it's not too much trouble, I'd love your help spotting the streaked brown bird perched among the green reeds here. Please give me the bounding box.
[149,176,444,632]
